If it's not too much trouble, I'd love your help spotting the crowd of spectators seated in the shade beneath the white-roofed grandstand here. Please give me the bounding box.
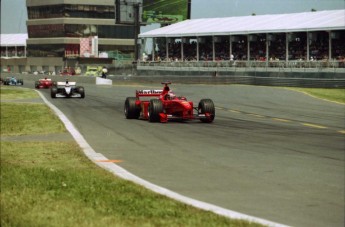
[144,31,345,66]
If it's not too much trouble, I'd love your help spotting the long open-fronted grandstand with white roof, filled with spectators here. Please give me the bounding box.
[138,9,345,72]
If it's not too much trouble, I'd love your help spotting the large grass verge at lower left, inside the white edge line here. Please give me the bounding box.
[0,88,261,227]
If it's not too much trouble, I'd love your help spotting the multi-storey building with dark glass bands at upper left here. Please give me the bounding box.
[26,0,135,71]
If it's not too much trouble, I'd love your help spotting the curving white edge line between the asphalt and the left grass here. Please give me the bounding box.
[35,90,287,227]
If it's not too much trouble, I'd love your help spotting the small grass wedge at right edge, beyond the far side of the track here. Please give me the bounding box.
[292,88,345,103]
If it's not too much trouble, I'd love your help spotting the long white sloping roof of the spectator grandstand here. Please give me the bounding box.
[139,10,345,38]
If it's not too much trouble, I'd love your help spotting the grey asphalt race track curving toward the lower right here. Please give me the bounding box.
[25,80,345,227]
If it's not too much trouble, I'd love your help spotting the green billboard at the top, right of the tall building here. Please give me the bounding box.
[142,0,191,24]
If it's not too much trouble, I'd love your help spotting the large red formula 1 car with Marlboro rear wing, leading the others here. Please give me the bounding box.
[124,82,215,123]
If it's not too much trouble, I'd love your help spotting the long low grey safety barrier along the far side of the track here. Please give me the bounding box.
[7,71,345,88]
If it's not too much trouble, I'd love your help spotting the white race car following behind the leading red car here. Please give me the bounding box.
[50,80,85,99]
